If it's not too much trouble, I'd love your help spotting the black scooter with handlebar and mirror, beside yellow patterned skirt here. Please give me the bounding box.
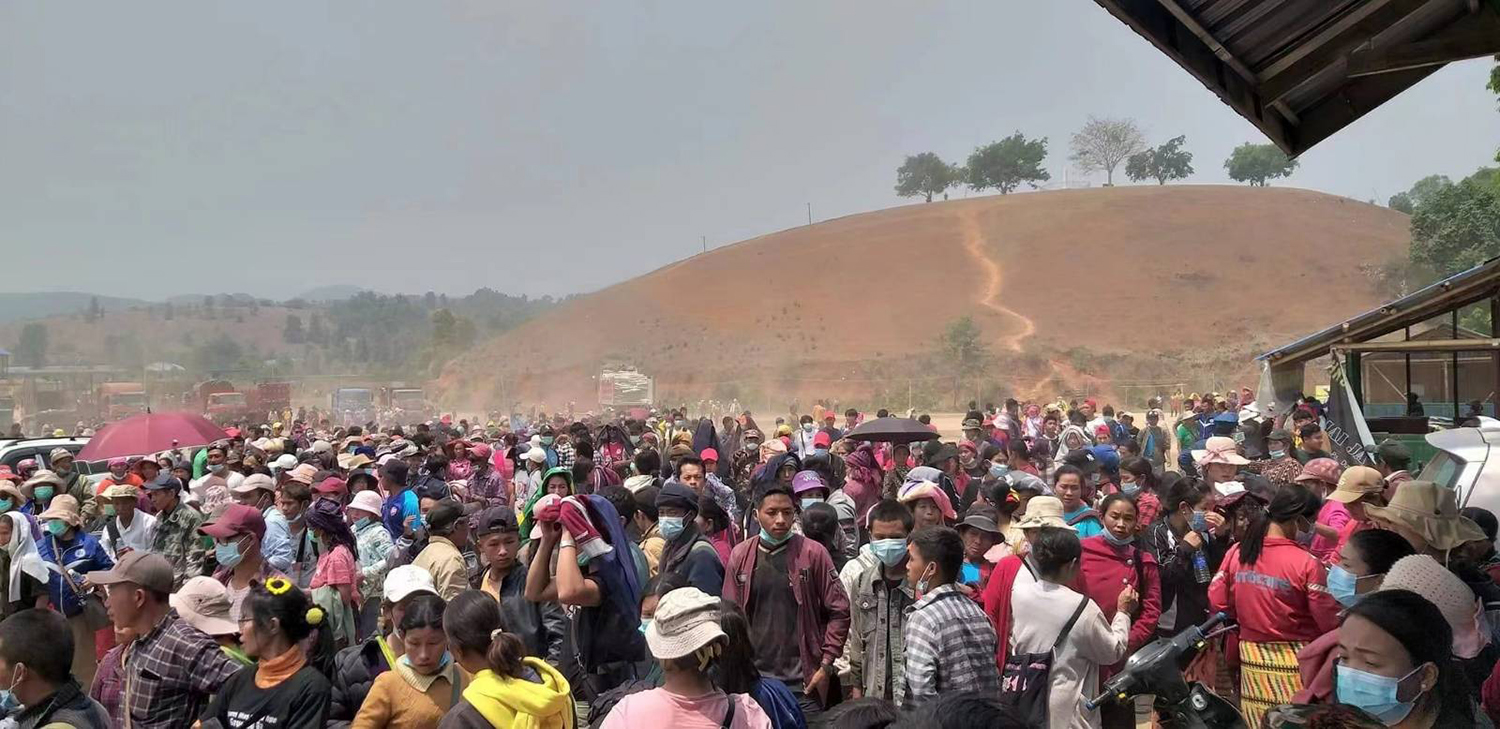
[1086,612,1245,729]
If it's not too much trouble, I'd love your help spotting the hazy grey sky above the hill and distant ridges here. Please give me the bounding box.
[0,0,1500,297]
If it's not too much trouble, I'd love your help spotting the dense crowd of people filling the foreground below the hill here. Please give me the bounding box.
[0,392,1500,729]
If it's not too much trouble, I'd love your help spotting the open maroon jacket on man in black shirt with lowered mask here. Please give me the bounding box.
[723,534,849,678]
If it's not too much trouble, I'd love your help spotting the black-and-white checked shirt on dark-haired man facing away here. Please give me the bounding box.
[902,584,1001,708]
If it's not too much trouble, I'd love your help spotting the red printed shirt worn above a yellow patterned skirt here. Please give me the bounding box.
[1209,537,1340,644]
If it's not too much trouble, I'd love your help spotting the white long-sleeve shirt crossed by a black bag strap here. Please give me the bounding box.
[1010,579,1130,729]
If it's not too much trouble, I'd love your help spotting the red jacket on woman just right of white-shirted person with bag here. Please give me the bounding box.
[1073,536,1161,657]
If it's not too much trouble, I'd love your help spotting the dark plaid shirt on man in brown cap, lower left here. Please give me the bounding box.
[122,611,243,729]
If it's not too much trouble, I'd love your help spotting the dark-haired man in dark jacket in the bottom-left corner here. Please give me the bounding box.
[0,609,111,729]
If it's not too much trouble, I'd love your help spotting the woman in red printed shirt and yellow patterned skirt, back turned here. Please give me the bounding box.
[1209,485,1338,726]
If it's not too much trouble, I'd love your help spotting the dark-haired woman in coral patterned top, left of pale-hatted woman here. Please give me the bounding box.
[308,498,360,650]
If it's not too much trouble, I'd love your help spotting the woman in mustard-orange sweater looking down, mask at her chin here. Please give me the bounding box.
[351,594,471,729]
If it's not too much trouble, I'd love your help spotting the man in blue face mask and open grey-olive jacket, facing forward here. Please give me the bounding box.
[845,500,917,704]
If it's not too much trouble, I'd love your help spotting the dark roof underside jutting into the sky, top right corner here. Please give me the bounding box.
[1095,0,1500,155]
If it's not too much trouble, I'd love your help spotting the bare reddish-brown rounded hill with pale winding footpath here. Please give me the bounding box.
[438,186,1410,410]
